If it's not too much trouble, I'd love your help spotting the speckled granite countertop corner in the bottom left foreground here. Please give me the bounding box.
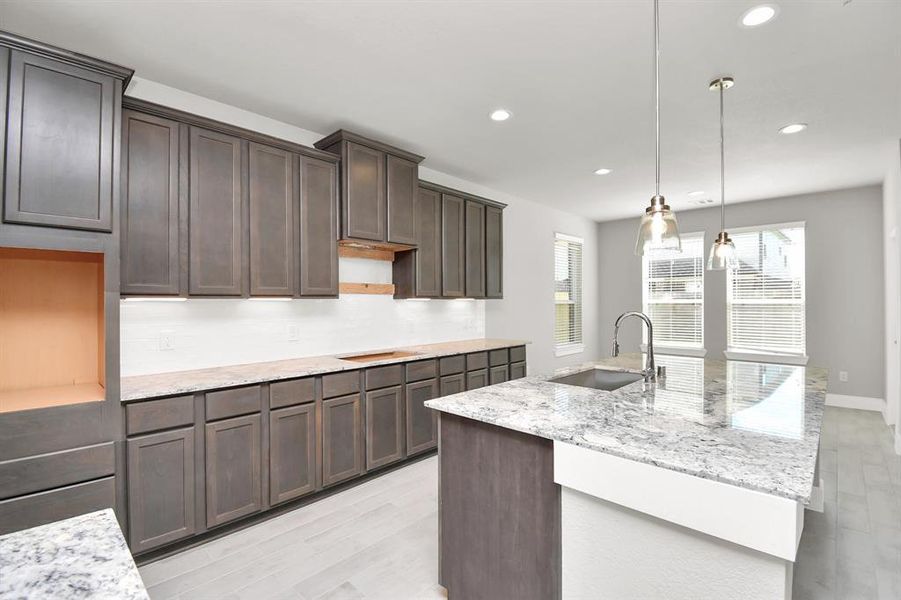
[0,509,148,600]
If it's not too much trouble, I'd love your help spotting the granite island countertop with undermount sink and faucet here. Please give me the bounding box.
[425,354,828,504]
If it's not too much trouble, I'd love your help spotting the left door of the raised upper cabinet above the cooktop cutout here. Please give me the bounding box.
[342,142,387,242]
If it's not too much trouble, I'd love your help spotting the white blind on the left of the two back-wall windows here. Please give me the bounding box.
[642,232,704,348]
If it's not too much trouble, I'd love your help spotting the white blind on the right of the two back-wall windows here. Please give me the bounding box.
[726,223,806,356]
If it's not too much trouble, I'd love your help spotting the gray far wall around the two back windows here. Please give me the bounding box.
[597,186,885,398]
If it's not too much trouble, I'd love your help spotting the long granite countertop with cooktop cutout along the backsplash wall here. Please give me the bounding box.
[121,339,528,402]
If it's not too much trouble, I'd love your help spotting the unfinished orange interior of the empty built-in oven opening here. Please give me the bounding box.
[0,248,105,413]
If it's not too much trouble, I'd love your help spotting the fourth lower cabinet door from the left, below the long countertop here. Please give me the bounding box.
[322,394,363,486]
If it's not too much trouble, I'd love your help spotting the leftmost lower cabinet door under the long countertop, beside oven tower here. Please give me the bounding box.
[127,428,196,553]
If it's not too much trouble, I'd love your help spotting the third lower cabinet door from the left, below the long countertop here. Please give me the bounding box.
[269,403,316,505]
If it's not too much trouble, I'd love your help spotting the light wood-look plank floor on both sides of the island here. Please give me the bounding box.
[140,408,901,600]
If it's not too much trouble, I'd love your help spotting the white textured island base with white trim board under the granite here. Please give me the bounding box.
[554,442,804,600]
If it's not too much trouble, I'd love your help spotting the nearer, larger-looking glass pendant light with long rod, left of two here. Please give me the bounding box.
[635,0,682,256]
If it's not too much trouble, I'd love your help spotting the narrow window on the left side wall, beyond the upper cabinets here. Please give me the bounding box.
[554,233,584,356]
